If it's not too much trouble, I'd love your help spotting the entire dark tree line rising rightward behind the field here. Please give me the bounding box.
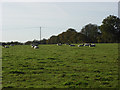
[0,15,120,45]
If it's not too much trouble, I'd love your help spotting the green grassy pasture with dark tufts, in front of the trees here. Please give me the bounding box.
[2,44,118,88]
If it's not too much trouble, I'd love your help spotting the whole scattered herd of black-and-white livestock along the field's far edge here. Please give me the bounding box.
[2,43,96,49]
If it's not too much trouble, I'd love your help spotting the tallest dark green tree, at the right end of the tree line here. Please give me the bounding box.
[100,15,120,42]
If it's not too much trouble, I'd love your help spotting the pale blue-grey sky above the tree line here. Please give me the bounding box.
[0,2,118,42]
